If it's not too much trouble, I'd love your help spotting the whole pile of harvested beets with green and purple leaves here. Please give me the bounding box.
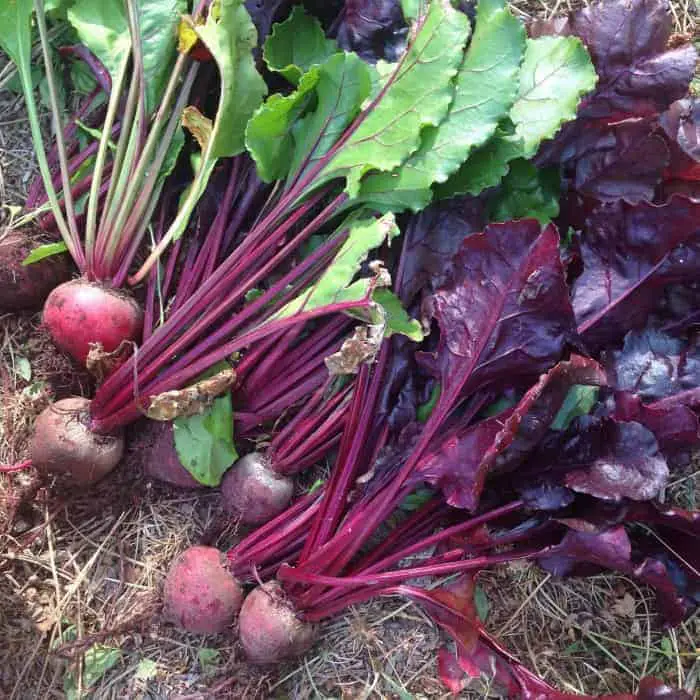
[0,0,700,700]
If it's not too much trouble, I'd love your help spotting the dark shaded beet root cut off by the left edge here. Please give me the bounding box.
[0,227,70,312]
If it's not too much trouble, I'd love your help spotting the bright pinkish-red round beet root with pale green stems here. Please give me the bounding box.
[43,280,143,365]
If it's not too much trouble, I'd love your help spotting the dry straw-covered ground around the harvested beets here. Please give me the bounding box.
[0,0,700,700]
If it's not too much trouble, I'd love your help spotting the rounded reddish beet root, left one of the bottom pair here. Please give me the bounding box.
[163,545,243,634]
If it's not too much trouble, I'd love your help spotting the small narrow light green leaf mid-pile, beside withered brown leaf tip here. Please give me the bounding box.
[272,214,399,320]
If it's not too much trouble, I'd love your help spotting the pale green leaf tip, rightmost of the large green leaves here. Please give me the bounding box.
[510,37,597,158]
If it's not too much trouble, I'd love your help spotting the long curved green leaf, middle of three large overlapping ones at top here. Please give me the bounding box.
[360,0,525,211]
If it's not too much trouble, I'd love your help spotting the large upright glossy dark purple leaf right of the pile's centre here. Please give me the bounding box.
[422,220,573,404]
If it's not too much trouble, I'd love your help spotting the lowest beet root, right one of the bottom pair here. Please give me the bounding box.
[239,581,316,665]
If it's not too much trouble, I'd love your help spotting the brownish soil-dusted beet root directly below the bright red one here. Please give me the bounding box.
[31,397,124,485]
